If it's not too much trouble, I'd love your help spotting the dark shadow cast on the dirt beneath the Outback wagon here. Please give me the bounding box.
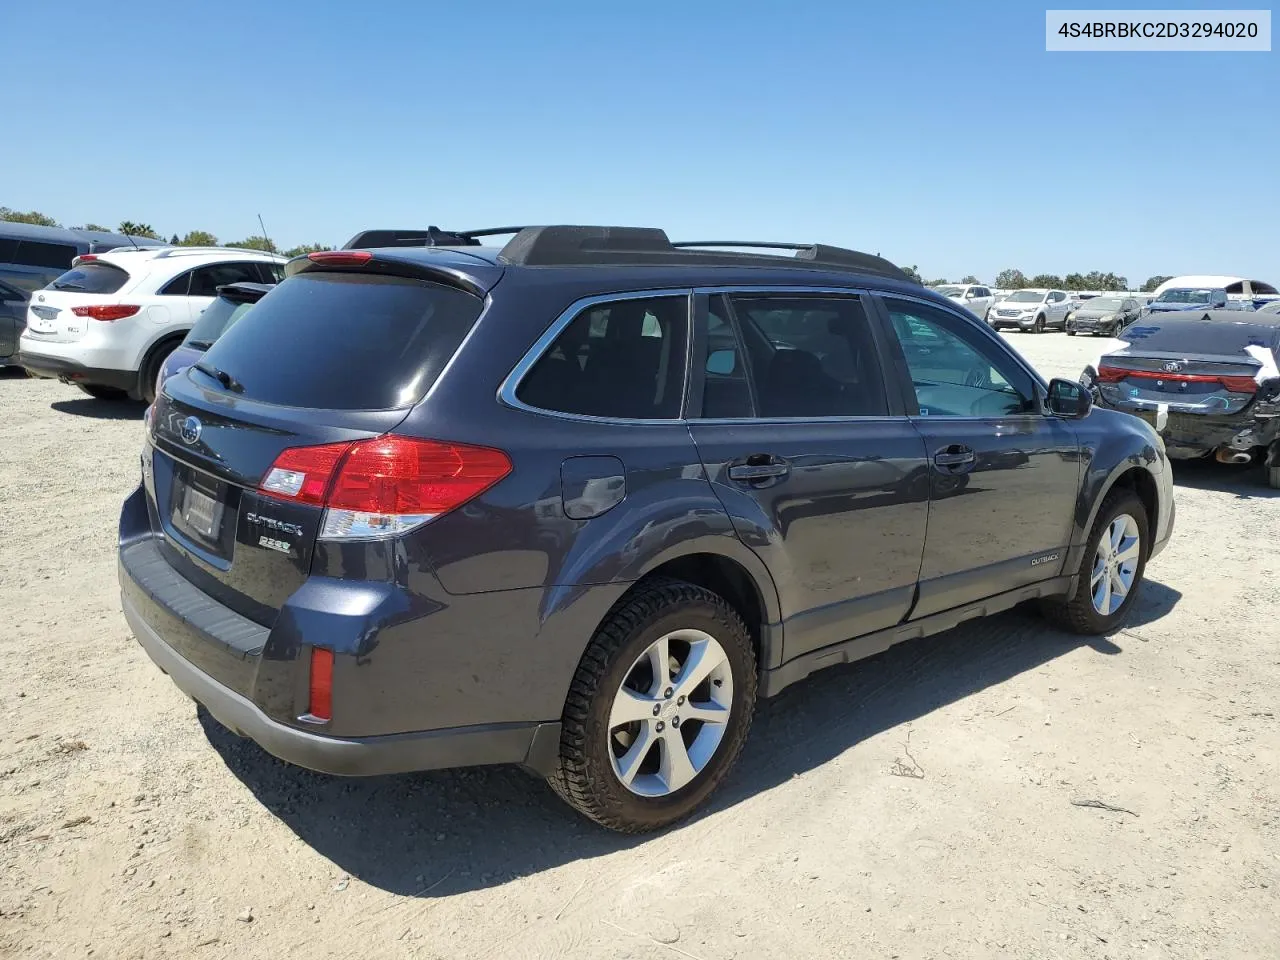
[200,581,1181,897]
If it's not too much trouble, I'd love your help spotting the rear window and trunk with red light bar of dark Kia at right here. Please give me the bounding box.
[1097,317,1276,416]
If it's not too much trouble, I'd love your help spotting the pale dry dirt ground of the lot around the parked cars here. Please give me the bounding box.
[0,334,1280,960]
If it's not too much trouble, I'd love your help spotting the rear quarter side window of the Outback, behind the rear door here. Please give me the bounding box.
[516,296,689,420]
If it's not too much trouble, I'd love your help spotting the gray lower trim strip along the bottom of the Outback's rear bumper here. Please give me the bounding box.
[123,596,559,777]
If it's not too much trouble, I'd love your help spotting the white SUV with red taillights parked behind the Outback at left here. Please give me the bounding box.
[18,247,287,402]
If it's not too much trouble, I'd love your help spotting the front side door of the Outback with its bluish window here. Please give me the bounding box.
[879,294,1080,618]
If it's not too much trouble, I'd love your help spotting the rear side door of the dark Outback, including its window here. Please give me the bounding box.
[689,291,929,659]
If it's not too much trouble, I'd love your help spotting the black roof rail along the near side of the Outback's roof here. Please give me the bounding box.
[488,227,914,283]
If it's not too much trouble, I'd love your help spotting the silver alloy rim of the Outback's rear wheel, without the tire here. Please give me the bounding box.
[608,630,733,797]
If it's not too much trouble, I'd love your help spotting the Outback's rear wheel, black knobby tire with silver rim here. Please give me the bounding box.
[549,580,756,833]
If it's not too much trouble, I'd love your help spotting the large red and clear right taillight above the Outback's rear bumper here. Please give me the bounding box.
[259,435,511,539]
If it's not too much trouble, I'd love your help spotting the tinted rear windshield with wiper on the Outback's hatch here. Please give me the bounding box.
[197,273,484,410]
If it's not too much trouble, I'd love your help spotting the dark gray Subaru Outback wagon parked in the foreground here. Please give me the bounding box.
[119,227,1174,831]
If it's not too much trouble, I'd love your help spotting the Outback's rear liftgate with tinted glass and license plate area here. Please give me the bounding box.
[143,261,494,626]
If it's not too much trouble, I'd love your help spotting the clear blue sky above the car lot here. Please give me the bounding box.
[0,0,1280,283]
